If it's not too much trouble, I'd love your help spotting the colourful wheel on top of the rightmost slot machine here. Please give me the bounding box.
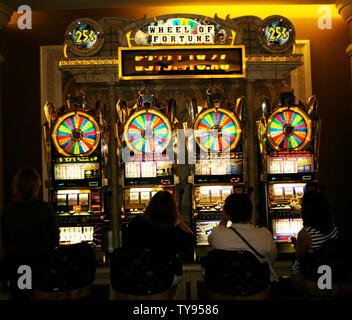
[267,107,312,150]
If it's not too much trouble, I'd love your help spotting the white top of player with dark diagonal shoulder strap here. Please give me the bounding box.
[208,223,278,281]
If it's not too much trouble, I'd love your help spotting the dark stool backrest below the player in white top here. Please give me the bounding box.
[203,249,270,296]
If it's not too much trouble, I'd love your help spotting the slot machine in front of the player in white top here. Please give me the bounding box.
[188,88,248,255]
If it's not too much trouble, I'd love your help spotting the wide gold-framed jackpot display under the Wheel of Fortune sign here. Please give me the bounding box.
[119,46,245,80]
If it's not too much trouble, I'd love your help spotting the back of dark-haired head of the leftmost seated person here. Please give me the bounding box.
[12,167,41,201]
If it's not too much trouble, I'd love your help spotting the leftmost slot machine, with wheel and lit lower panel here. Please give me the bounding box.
[44,97,108,257]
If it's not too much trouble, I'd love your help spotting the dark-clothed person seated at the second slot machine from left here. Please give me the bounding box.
[124,191,194,298]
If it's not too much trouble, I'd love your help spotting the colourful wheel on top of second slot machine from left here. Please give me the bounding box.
[123,109,172,153]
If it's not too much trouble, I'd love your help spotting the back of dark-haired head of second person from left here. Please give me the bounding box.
[143,191,179,227]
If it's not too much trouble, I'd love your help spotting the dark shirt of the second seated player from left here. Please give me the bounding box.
[124,216,194,254]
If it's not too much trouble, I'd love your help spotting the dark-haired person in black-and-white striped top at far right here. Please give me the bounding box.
[292,190,338,277]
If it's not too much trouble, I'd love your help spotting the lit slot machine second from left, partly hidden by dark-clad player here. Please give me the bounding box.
[116,87,179,239]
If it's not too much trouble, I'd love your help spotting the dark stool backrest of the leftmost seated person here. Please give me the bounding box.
[33,242,96,292]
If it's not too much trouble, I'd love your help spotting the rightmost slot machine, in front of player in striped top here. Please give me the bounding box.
[257,92,320,254]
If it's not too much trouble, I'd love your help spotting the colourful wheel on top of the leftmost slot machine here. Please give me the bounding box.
[51,111,100,156]
